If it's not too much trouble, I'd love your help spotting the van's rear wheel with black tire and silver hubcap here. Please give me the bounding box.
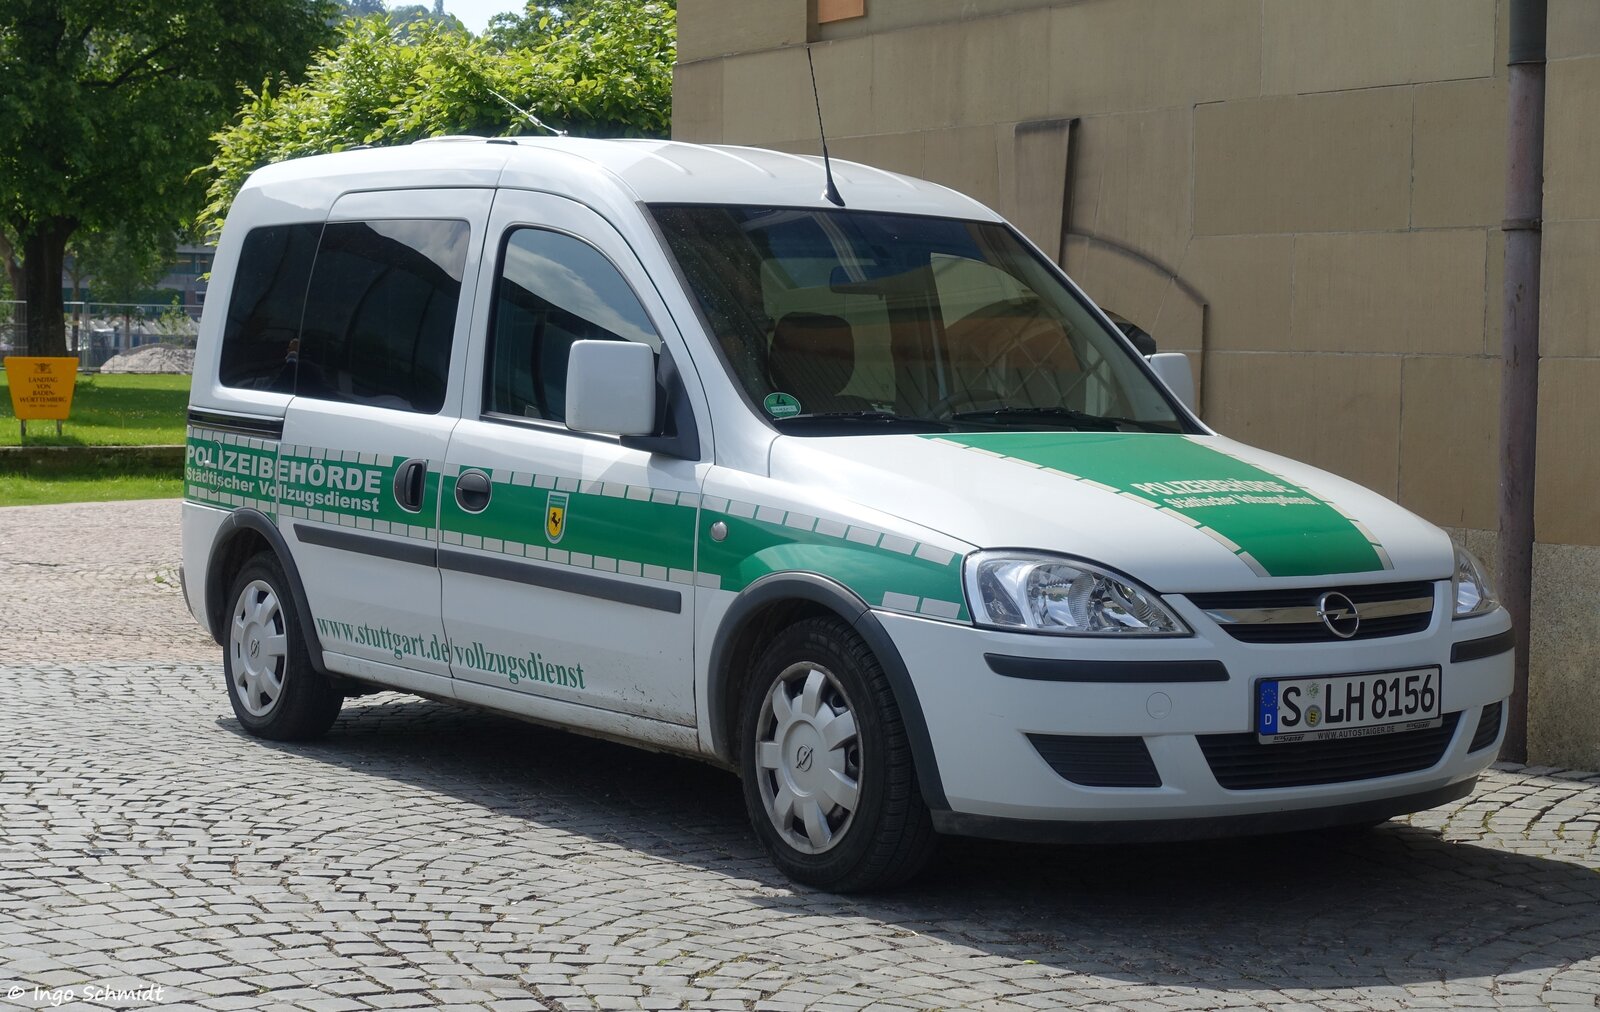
[222,552,344,741]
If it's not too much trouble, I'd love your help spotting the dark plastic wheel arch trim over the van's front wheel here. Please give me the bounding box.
[706,573,949,810]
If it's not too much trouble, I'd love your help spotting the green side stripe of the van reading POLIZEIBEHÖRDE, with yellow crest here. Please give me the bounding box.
[186,429,966,621]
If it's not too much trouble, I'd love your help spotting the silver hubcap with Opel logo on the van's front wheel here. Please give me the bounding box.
[755,663,861,853]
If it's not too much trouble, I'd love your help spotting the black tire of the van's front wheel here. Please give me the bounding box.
[739,618,938,892]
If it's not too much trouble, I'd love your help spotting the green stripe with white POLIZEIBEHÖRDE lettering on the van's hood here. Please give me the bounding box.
[926,432,1392,576]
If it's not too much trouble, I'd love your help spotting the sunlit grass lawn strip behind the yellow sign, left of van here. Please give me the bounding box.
[0,370,189,445]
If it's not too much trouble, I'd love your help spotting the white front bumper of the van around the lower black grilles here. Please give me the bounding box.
[877,599,1512,841]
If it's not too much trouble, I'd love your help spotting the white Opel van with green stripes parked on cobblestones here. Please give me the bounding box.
[184,138,1512,890]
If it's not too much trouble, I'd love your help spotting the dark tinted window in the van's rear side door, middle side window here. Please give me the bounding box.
[296,219,470,415]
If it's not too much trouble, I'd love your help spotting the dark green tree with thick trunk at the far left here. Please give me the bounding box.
[0,0,333,354]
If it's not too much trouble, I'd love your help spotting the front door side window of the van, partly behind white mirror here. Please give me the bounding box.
[483,227,661,421]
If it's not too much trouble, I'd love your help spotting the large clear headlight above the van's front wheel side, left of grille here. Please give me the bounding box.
[966,551,1190,636]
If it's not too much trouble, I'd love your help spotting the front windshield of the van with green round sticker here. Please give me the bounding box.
[651,205,1186,434]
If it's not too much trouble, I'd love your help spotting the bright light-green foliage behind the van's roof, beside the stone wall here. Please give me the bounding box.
[202,0,677,234]
